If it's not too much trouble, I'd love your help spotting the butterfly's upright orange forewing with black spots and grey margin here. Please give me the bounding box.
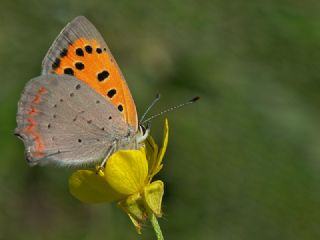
[42,16,138,130]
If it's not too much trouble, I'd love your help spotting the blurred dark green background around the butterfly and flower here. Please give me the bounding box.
[0,0,320,240]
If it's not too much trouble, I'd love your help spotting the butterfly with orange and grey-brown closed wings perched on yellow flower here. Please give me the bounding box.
[15,16,148,167]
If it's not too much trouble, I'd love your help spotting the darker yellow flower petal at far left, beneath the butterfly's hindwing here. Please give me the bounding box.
[69,170,124,203]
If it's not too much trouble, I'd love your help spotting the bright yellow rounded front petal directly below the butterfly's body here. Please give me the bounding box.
[105,150,148,195]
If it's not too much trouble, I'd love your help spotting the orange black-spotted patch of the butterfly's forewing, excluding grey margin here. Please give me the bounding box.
[53,38,138,130]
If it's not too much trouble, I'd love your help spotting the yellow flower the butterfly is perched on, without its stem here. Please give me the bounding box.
[69,119,168,233]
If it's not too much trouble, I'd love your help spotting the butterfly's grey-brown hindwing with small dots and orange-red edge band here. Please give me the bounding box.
[16,75,130,166]
